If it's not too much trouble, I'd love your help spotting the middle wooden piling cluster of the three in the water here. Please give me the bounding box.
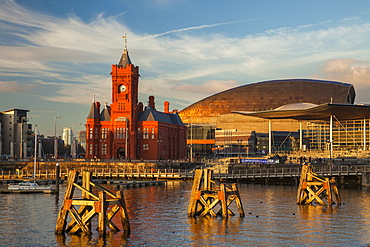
[188,169,245,218]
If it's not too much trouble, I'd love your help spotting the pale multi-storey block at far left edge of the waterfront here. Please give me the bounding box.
[0,109,33,159]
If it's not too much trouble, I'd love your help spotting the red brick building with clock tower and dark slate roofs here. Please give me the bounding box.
[85,43,187,160]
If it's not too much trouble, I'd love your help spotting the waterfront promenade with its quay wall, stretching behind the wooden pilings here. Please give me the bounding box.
[0,159,370,187]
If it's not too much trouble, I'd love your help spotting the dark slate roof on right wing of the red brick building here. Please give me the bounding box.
[139,106,184,125]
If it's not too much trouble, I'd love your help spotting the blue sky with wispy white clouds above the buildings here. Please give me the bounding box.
[0,0,370,135]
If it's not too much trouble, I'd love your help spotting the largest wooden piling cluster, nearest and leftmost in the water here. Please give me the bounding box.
[55,171,130,235]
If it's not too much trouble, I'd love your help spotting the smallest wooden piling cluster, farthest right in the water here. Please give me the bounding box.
[297,164,341,206]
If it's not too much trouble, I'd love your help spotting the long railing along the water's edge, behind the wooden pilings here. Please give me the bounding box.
[0,165,370,179]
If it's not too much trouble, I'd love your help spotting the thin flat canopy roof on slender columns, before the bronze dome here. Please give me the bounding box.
[233,103,370,120]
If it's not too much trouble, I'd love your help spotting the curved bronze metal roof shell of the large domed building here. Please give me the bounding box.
[179,79,356,121]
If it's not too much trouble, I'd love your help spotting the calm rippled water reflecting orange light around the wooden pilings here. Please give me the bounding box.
[0,181,370,246]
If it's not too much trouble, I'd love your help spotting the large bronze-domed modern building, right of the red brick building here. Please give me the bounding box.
[179,79,370,156]
